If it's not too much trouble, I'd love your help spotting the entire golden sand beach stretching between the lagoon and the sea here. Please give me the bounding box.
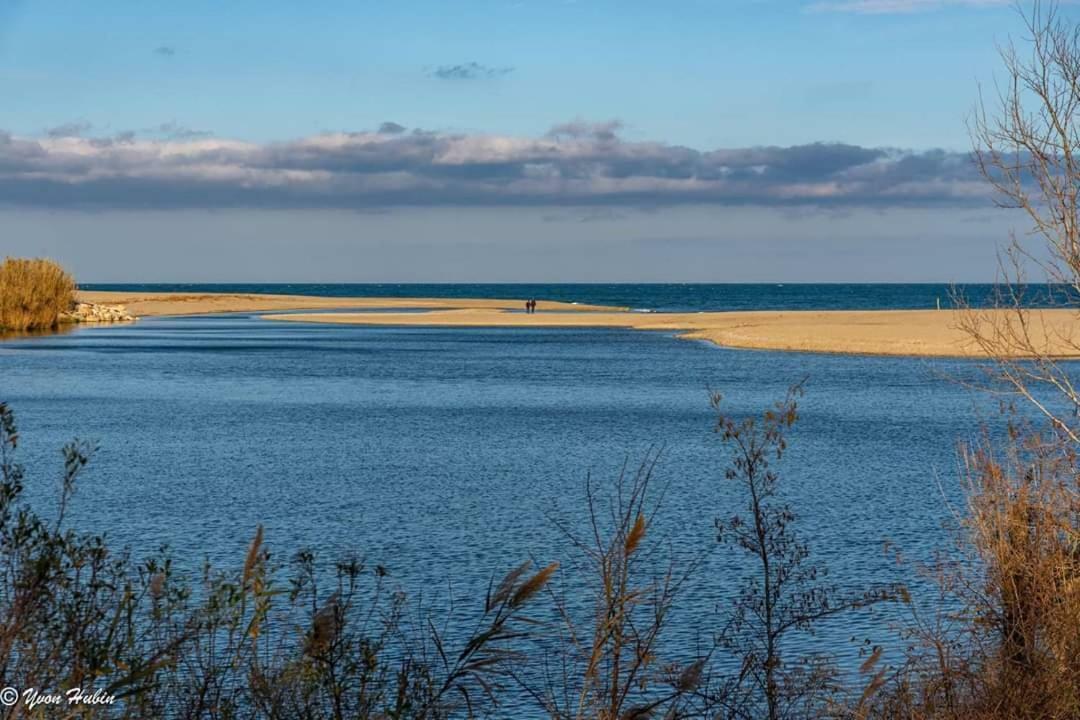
[79,291,1080,358]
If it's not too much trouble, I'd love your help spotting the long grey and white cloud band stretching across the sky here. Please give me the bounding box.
[0,122,987,208]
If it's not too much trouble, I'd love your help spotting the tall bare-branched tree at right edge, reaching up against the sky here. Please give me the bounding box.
[959,2,1080,443]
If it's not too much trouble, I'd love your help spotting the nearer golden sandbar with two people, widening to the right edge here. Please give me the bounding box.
[259,308,1080,357]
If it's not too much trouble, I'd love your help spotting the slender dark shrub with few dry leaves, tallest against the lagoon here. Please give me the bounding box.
[712,384,904,720]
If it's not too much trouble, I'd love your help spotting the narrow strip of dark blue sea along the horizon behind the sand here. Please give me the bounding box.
[83,283,1058,312]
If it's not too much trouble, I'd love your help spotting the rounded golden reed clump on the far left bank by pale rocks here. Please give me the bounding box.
[0,258,76,330]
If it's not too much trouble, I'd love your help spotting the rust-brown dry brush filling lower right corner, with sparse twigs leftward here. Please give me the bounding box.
[870,431,1080,720]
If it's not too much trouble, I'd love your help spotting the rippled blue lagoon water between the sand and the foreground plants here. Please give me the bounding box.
[0,284,1010,686]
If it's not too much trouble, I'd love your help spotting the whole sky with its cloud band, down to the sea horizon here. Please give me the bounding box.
[0,0,1074,282]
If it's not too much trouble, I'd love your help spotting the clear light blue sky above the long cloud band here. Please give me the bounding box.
[0,0,1017,149]
